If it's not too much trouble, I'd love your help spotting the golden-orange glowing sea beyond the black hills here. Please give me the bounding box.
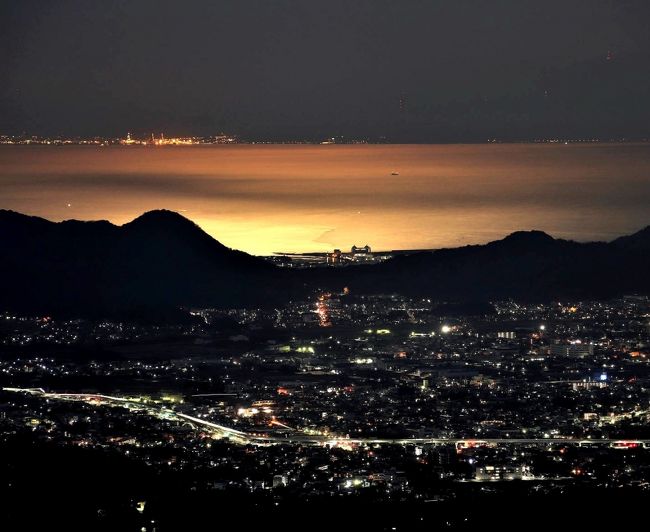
[0,144,650,254]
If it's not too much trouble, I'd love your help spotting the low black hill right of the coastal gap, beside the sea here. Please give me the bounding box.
[322,228,650,301]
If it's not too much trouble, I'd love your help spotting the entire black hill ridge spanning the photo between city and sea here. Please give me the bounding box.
[0,207,650,316]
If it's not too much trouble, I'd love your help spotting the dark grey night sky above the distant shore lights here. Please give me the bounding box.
[0,0,650,141]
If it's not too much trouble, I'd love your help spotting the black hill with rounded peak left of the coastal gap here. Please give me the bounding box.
[0,211,282,315]
